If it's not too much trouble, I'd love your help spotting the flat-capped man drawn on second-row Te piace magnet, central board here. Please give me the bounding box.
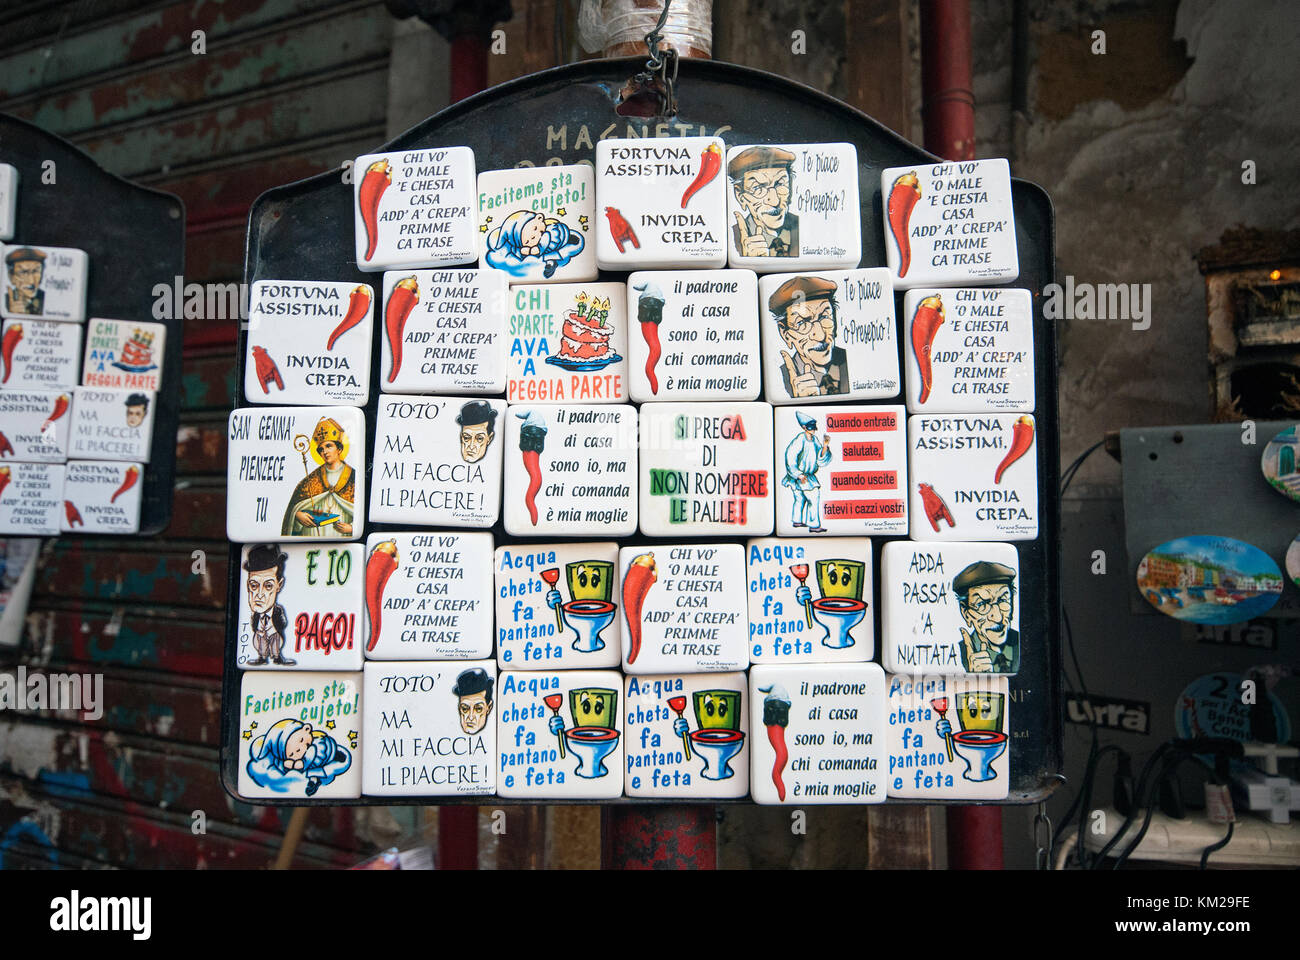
[767,277,849,397]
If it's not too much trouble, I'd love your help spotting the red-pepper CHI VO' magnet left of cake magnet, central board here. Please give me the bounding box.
[380,268,506,394]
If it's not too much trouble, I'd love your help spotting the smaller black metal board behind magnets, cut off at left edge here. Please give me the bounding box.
[0,113,185,540]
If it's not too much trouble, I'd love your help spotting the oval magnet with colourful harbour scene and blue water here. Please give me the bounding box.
[1138,536,1283,623]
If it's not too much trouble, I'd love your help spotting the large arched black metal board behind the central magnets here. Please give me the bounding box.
[221,59,1063,807]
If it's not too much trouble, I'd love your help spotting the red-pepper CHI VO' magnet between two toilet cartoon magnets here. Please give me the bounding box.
[619,544,749,674]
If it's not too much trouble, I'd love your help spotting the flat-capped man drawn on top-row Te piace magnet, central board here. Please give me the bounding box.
[727,147,800,256]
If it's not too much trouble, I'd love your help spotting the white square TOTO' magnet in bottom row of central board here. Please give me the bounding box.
[361,660,497,796]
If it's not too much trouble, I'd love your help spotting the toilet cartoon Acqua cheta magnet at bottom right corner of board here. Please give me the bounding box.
[885,675,1011,800]
